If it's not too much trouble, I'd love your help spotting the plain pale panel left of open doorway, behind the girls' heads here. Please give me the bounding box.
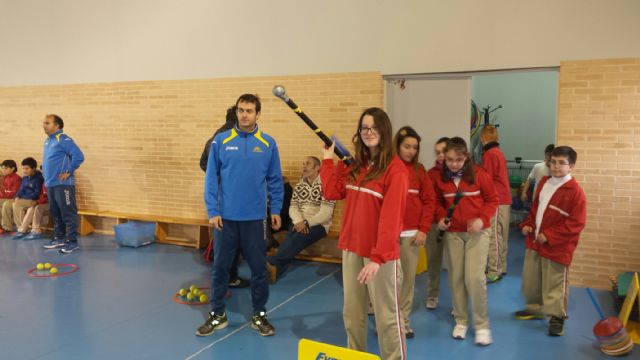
[385,76,471,169]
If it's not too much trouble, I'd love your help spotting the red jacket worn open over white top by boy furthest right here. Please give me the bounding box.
[520,176,587,266]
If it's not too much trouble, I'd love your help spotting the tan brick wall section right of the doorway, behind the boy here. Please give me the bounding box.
[558,59,640,288]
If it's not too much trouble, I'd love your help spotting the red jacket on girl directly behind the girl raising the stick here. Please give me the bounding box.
[402,162,436,234]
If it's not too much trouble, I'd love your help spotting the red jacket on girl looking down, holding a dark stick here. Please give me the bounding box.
[435,166,499,232]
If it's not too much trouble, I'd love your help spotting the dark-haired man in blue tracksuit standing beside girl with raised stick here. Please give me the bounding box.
[196,94,284,336]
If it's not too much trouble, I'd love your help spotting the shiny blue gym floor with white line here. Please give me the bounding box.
[0,231,640,360]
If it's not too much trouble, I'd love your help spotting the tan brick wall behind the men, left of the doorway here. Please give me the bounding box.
[0,73,383,236]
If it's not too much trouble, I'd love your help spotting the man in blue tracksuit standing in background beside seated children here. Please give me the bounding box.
[42,114,84,254]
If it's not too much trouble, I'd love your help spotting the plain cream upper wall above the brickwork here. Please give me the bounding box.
[0,0,640,86]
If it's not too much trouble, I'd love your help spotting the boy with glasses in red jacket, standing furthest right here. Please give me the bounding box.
[514,146,587,336]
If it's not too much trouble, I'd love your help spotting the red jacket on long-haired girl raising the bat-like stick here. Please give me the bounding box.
[320,156,409,264]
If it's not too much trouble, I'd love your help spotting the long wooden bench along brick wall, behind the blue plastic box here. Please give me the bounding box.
[78,210,211,249]
